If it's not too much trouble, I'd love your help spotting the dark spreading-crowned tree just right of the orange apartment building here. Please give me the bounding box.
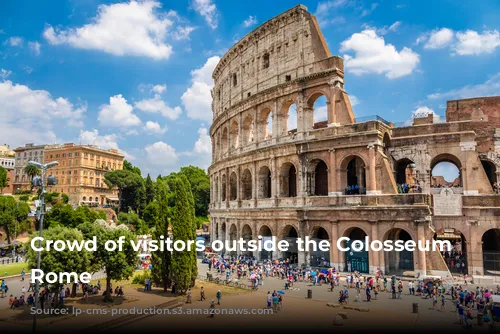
[104,169,144,211]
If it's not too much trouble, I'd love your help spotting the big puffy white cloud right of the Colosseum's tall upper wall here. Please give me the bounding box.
[340,30,420,79]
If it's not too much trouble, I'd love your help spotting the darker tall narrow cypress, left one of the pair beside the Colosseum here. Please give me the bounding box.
[149,180,172,291]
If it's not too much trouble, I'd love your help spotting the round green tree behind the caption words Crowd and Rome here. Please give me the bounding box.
[27,226,92,301]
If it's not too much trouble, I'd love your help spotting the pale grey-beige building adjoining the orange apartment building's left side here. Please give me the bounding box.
[13,143,47,192]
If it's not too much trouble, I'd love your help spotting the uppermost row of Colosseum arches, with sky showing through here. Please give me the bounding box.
[212,92,329,156]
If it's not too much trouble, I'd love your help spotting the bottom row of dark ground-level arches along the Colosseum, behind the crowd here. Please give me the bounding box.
[213,222,500,275]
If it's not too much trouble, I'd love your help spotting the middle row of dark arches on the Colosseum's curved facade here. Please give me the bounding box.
[214,156,366,202]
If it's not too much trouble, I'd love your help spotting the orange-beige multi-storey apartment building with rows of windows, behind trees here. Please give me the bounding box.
[44,143,124,206]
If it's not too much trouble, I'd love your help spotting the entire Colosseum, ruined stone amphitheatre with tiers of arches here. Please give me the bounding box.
[209,5,500,282]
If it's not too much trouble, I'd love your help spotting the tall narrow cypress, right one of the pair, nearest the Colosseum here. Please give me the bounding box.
[171,174,198,291]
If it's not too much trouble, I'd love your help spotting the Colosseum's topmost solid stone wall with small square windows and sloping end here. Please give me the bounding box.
[212,5,344,118]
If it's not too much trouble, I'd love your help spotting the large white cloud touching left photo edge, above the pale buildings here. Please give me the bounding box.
[0,80,87,126]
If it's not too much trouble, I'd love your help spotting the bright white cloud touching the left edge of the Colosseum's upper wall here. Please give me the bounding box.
[181,56,220,122]
